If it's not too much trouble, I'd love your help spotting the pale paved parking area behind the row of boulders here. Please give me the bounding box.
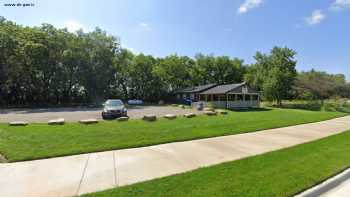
[0,106,200,122]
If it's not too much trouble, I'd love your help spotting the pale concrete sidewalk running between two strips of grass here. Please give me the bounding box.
[0,116,350,197]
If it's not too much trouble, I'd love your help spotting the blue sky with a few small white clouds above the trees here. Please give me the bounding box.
[0,0,350,80]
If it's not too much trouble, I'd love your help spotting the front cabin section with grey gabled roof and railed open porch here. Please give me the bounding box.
[199,83,260,109]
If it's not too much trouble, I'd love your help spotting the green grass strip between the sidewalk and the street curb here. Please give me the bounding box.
[82,131,350,197]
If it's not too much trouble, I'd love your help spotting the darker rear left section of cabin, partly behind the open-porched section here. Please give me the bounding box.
[174,84,216,102]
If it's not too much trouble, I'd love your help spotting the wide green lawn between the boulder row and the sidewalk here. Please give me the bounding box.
[0,109,345,162]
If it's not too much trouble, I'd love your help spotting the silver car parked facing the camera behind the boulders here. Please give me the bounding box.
[102,99,127,119]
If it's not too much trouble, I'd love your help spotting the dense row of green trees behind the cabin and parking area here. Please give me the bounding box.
[0,17,349,106]
